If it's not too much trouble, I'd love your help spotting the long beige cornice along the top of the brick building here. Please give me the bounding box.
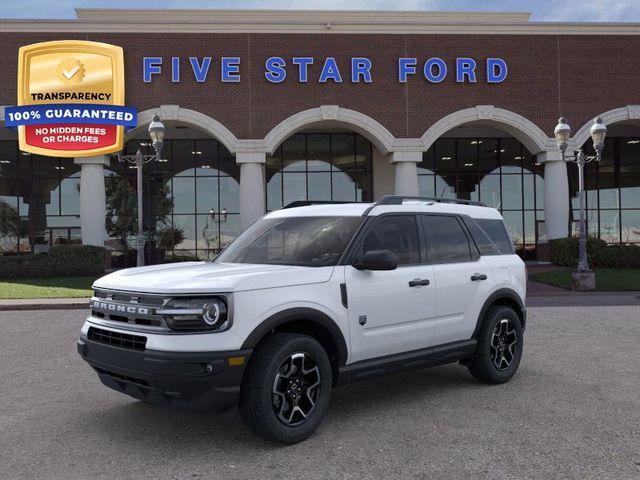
[0,8,640,35]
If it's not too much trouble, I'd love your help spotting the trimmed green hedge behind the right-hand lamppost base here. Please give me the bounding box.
[550,237,640,268]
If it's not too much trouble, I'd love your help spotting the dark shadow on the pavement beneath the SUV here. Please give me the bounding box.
[80,365,480,455]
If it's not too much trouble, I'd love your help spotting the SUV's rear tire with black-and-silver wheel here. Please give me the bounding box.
[468,305,524,384]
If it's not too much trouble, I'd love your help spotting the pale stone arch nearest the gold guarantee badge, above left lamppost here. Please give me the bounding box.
[125,105,238,154]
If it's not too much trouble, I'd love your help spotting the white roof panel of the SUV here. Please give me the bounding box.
[267,200,502,219]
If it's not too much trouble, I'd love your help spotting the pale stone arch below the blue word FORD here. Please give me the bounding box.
[421,105,554,154]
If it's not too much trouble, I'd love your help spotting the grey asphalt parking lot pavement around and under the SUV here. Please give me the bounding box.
[0,306,640,480]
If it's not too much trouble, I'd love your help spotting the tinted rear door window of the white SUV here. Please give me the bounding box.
[422,215,471,263]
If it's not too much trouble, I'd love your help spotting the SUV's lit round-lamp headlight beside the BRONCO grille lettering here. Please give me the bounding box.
[156,298,231,332]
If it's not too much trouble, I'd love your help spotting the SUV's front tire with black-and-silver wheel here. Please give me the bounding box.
[238,333,333,445]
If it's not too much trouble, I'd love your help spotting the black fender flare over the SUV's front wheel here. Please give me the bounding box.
[241,307,348,366]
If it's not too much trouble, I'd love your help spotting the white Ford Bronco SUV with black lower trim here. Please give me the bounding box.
[78,196,526,443]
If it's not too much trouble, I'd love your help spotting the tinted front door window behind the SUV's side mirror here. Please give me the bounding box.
[362,215,420,265]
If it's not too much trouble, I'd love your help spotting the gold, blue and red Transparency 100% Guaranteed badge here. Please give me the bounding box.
[5,40,137,157]
